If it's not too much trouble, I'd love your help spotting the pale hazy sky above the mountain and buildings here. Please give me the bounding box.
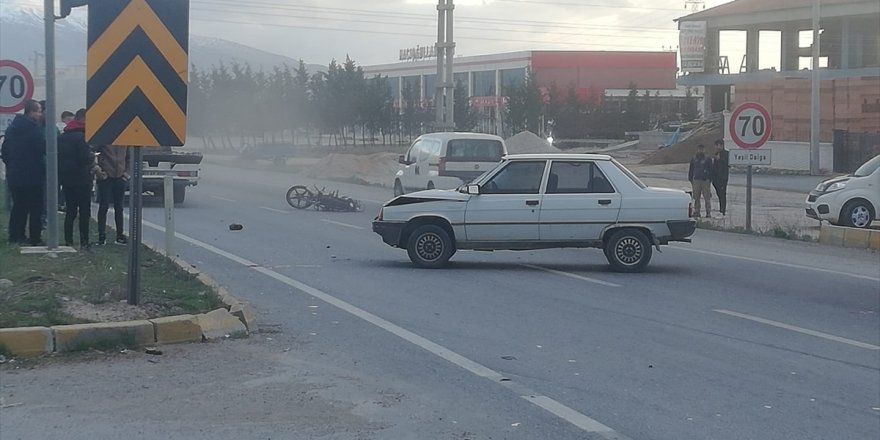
[0,0,730,65]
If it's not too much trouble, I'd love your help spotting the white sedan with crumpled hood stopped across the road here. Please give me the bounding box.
[373,154,696,272]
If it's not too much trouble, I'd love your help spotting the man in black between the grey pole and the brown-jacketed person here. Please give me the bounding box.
[58,109,95,249]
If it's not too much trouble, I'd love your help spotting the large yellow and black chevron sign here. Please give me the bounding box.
[86,0,189,147]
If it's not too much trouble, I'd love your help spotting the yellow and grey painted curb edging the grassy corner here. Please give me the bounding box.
[0,242,257,358]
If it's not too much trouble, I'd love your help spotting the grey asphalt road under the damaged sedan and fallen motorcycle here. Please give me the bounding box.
[0,164,880,440]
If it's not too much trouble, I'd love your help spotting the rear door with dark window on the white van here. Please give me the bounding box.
[439,139,504,182]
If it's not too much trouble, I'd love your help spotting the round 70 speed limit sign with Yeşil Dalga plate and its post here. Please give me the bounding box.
[727,102,772,232]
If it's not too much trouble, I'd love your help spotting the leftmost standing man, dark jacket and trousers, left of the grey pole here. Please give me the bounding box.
[0,100,46,246]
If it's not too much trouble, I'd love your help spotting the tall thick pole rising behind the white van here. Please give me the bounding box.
[434,0,455,131]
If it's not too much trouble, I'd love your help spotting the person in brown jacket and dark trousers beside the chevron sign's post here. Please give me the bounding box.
[95,145,128,245]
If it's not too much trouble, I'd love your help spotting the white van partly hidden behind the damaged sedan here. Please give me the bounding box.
[394,133,507,196]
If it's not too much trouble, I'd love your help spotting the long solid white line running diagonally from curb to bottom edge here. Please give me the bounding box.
[143,220,630,440]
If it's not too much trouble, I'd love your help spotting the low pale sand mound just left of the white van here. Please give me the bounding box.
[306,153,397,186]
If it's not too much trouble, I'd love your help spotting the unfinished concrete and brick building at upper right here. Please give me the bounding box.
[678,0,880,142]
